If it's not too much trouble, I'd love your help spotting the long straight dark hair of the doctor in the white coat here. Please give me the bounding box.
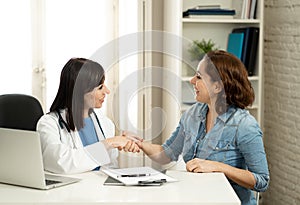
[50,58,105,131]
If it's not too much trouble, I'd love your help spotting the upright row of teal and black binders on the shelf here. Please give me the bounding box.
[227,27,259,76]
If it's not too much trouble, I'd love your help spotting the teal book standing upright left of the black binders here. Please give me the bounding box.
[227,33,244,59]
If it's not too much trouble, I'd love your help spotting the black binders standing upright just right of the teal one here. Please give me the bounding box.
[232,27,259,76]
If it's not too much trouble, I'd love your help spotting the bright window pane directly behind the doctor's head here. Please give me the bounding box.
[45,0,114,110]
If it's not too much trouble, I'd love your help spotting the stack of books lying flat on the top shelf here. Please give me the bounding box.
[182,5,235,18]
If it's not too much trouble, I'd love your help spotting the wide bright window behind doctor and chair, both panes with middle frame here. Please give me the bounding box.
[0,0,115,111]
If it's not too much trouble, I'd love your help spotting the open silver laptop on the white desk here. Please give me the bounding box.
[0,128,80,190]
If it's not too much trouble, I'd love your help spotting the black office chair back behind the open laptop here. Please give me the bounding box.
[0,94,44,131]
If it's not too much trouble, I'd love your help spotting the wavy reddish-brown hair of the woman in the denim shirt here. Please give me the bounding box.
[204,50,255,114]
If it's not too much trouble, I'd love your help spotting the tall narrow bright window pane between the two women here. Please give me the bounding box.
[118,0,139,133]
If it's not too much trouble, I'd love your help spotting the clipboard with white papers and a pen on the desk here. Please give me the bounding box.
[100,166,178,186]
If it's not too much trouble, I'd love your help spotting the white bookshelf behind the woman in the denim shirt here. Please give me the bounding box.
[164,0,264,138]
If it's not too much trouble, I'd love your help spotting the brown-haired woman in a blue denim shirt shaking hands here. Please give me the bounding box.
[124,51,270,205]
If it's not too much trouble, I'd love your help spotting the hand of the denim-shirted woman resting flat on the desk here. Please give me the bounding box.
[186,158,220,172]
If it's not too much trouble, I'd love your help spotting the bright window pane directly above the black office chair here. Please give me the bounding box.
[0,0,32,94]
